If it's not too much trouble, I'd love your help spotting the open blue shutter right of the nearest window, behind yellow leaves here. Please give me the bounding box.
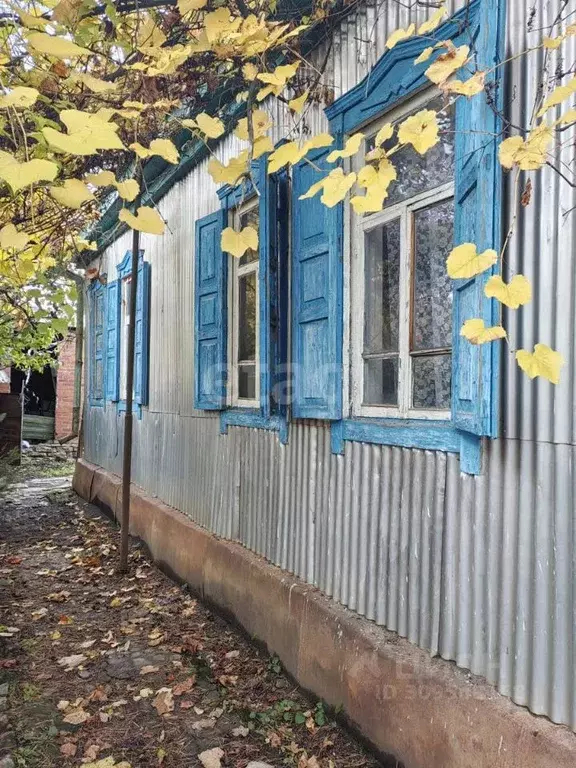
[452,0,504,437]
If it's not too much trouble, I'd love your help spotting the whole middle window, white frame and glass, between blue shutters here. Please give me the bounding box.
[228,198,260,408]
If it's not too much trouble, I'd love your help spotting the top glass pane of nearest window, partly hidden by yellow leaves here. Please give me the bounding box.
[366,97,454,206]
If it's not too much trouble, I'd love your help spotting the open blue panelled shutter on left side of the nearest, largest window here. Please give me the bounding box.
[292,149,342,419]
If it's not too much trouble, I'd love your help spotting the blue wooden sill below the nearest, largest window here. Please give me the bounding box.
[330,419,482,475]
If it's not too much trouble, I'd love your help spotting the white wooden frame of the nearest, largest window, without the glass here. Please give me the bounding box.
[344,89,454,421]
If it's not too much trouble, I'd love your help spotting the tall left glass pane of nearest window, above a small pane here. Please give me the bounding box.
[364,219,400,355]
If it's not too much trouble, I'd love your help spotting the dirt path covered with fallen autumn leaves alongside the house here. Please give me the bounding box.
[0,479,388,768]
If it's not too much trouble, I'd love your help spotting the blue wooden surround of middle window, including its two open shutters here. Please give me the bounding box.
[195,158,289,443]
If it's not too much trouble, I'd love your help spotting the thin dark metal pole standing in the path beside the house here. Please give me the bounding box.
[119,229,140,573]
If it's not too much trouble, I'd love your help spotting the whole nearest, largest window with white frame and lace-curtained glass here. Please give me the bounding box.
[350,97,454,419]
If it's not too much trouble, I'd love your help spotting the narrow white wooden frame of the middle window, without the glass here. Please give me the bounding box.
[227,197,260,408]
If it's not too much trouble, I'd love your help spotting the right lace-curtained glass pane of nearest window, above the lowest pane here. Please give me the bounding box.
[411,200,454,351]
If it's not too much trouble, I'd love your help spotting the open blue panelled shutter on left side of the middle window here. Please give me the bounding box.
[194,211,228,410]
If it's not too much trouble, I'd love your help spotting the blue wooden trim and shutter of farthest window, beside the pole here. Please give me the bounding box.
[111,250,151,419]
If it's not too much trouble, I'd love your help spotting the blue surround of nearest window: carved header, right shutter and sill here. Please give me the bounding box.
[326,0,505,474]
